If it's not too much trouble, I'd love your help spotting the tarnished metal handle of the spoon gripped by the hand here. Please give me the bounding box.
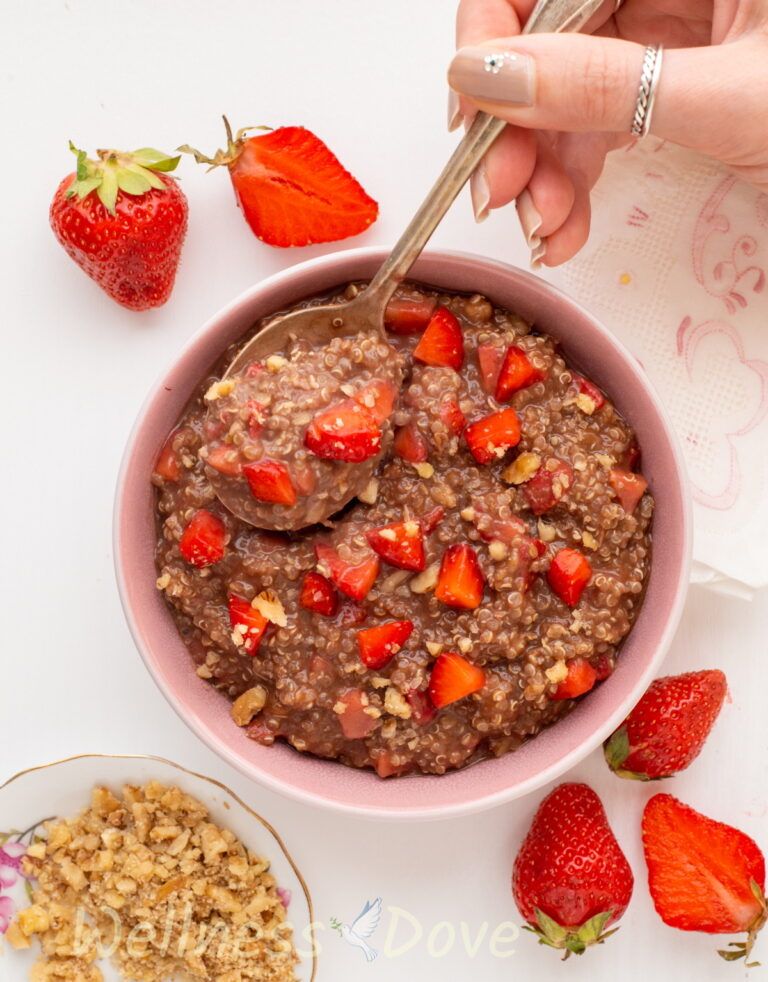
[366,0,604,305]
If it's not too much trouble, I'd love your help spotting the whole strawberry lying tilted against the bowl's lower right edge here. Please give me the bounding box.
[604,669,727,781]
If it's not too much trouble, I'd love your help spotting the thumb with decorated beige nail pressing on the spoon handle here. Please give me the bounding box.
[448,34,768,156]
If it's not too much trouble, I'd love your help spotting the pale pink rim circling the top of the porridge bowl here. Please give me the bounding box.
[112,246,693,821]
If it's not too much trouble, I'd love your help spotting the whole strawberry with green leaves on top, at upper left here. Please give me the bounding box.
[50,143,187,310]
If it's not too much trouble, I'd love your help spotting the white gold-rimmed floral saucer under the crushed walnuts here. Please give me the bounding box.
[0,754,317,982]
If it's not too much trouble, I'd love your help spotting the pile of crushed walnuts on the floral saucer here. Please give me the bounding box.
[6,781,298,982]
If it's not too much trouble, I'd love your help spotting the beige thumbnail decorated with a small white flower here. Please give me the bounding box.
[448,47,535,106]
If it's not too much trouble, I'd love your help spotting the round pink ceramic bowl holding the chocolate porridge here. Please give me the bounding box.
[114,249,691,819]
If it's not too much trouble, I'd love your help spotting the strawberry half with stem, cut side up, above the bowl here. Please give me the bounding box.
[184,117,379,247]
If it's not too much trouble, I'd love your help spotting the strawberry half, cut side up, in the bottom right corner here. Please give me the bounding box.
[643,794,768,961]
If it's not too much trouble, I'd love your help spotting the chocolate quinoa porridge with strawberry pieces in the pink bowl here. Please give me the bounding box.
[153,285,653,777]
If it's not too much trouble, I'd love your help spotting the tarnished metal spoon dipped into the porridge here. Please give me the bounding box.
[211,0,603,530]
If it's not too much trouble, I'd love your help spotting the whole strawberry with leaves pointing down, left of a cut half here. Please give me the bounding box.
[512,784,633,958]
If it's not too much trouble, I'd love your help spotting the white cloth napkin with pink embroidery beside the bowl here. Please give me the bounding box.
[545,139,768,598]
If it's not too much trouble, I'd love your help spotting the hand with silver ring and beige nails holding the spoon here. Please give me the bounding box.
[448,0,768,266]
